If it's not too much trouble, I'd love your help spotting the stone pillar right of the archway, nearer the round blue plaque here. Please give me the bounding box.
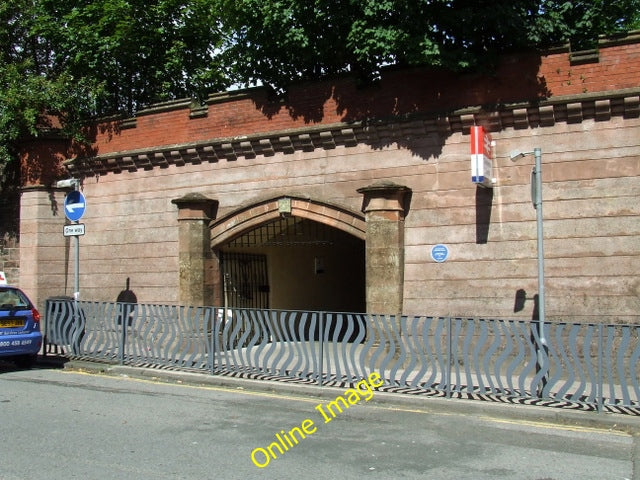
[358,182,411,315]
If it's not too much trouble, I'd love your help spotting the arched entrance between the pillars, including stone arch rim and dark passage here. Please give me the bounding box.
[210,196,366,312]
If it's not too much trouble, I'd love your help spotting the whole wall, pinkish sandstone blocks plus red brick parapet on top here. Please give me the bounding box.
[21,34,640,322]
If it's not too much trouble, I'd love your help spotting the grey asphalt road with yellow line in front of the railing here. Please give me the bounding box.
[21,356,640,480]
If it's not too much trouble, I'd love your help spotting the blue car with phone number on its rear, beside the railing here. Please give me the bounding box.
[0,272,42,367]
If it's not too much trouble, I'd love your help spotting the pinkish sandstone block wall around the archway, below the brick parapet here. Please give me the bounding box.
[51,112,640,321]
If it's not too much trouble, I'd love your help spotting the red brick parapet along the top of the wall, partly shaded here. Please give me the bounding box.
[76,37,640,155]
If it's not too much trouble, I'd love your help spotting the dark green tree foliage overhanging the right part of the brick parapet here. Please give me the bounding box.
[221,0,640,90]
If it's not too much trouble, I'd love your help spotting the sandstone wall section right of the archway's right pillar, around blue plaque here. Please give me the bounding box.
[405,119,640,322]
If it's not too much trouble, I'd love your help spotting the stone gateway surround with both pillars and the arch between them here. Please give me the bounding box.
[172,186,411,314]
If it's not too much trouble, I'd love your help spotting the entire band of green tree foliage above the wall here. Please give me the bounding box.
[0,0,640,172]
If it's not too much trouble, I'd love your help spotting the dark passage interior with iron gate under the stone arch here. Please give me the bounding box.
[220,216,366,312]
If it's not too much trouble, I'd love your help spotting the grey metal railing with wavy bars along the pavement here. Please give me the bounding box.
[45,299,640,413]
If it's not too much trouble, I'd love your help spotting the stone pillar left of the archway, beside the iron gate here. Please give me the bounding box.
[171,193,219,306]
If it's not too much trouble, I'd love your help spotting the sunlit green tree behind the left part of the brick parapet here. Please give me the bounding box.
[35,0,226,114]
